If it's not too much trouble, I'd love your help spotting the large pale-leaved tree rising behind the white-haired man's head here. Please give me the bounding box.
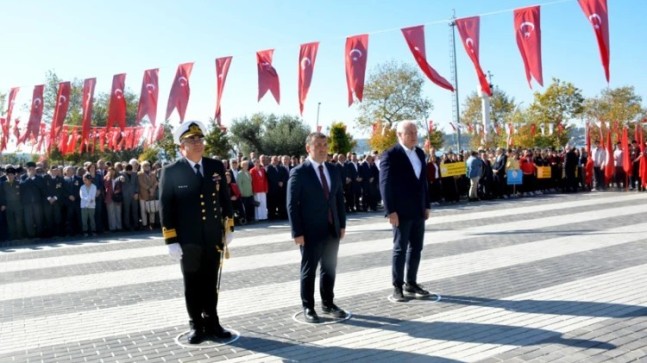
[355,61,433,130]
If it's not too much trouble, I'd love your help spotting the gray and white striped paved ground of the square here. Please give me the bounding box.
[0,193,647,362]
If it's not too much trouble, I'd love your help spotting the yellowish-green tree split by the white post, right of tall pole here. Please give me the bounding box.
[461,87,515,149]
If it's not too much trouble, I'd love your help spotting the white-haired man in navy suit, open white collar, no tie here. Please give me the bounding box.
[380,121,431,301]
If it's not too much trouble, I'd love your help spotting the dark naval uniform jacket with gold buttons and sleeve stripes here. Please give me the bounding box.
[160,157,233,247]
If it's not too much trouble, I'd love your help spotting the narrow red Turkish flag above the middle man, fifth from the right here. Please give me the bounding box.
[346,34,368,106]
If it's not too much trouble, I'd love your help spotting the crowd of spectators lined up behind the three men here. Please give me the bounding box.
[0,138,647,240]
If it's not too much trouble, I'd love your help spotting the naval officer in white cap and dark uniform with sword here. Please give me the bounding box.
[160,121,233,344]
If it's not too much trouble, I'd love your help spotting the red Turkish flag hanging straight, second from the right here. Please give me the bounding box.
[514,6,544,88]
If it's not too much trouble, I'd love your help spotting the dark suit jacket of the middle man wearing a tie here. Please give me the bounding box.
[287,160,346,243]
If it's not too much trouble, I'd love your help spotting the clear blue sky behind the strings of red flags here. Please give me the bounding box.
[0,0,647,140]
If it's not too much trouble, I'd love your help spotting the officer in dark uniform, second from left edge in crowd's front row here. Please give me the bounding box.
[20,161,45,238]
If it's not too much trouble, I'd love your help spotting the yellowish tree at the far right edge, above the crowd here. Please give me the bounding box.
[584,86,645,141]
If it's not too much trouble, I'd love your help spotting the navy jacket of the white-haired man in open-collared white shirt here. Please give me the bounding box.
[380,143,431,219]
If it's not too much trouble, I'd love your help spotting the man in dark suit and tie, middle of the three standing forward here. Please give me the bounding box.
[287,132,347,323]
